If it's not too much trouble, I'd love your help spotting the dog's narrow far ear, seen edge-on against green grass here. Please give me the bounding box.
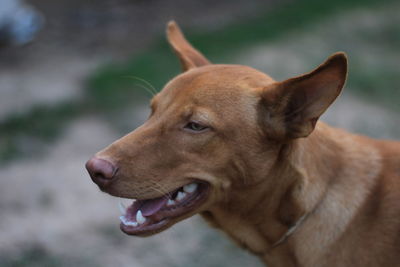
[167,21,210,71]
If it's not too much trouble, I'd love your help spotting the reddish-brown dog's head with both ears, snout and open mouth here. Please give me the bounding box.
[86,22,346,238]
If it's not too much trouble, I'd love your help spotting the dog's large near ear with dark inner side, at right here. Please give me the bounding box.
[262,52,347,138]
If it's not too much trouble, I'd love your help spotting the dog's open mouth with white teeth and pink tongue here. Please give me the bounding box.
[120,182,209,235]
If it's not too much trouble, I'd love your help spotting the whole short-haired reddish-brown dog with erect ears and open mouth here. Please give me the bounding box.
[86,22,400,267]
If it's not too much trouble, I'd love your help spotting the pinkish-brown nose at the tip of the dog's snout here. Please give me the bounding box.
[86,157,117,187]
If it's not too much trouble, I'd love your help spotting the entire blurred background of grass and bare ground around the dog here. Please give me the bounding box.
[0,0,400,267]
